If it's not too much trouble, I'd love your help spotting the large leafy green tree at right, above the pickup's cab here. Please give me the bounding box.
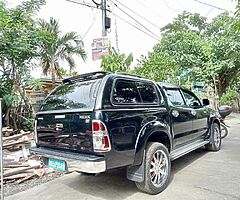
[136,12,240,98]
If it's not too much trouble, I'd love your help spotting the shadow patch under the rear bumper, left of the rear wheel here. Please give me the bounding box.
[65,168,138,200]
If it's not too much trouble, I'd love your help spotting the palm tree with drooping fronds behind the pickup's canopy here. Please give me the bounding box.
[39,18,86,87]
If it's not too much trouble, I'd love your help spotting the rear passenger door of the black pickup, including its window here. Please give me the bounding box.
[165,88,194,148]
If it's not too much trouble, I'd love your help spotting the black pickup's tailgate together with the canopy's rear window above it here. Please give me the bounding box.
[36,79,101,152]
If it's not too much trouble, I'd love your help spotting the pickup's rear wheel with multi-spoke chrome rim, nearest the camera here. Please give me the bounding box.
[135,142,171,194]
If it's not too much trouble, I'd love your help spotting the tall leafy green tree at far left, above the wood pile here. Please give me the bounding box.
[0,0,45,128]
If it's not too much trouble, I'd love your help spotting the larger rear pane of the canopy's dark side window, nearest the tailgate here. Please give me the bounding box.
[113,80,141,104]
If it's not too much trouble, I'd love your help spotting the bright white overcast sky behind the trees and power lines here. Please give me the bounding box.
[6,0,236,77]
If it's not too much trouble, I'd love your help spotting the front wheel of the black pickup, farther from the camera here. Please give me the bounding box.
[205,123,222,151]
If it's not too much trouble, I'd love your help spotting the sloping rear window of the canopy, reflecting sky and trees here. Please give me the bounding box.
[40,80,100,111]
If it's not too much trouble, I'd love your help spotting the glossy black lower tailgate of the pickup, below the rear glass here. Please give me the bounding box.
[36,112,93,152]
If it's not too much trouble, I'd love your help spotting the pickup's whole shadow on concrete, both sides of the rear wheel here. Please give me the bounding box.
[65,149,207,200]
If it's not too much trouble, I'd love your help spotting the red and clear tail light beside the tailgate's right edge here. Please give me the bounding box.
[92,120,111,152]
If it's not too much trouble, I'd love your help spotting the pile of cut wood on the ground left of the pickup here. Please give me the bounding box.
[2,127,51,183]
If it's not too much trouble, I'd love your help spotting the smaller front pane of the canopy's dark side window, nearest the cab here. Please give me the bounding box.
[137,83,158,104]
